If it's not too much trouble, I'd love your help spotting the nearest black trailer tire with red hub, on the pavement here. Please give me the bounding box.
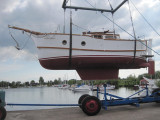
[82,96,101,116]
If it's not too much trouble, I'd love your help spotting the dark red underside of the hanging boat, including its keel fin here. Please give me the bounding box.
[39,55,153,80]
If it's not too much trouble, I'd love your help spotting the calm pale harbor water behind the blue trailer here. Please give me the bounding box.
[4,87,136,111]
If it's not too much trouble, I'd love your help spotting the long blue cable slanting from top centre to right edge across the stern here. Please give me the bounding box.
[85,0,160,56]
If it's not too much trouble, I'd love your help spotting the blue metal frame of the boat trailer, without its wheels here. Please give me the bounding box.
[97,85,160,110]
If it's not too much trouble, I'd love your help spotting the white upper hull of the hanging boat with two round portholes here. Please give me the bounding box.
[32,34,150,59]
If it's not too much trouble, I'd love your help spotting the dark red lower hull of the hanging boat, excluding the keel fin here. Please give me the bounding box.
[39,55,150,70]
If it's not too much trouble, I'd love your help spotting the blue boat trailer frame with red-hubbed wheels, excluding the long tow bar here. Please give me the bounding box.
[81,84,160,116]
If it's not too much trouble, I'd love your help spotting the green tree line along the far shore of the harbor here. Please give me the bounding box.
[0,71,160,88]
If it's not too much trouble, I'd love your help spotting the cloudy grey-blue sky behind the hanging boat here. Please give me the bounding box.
[0,0,160,82]
